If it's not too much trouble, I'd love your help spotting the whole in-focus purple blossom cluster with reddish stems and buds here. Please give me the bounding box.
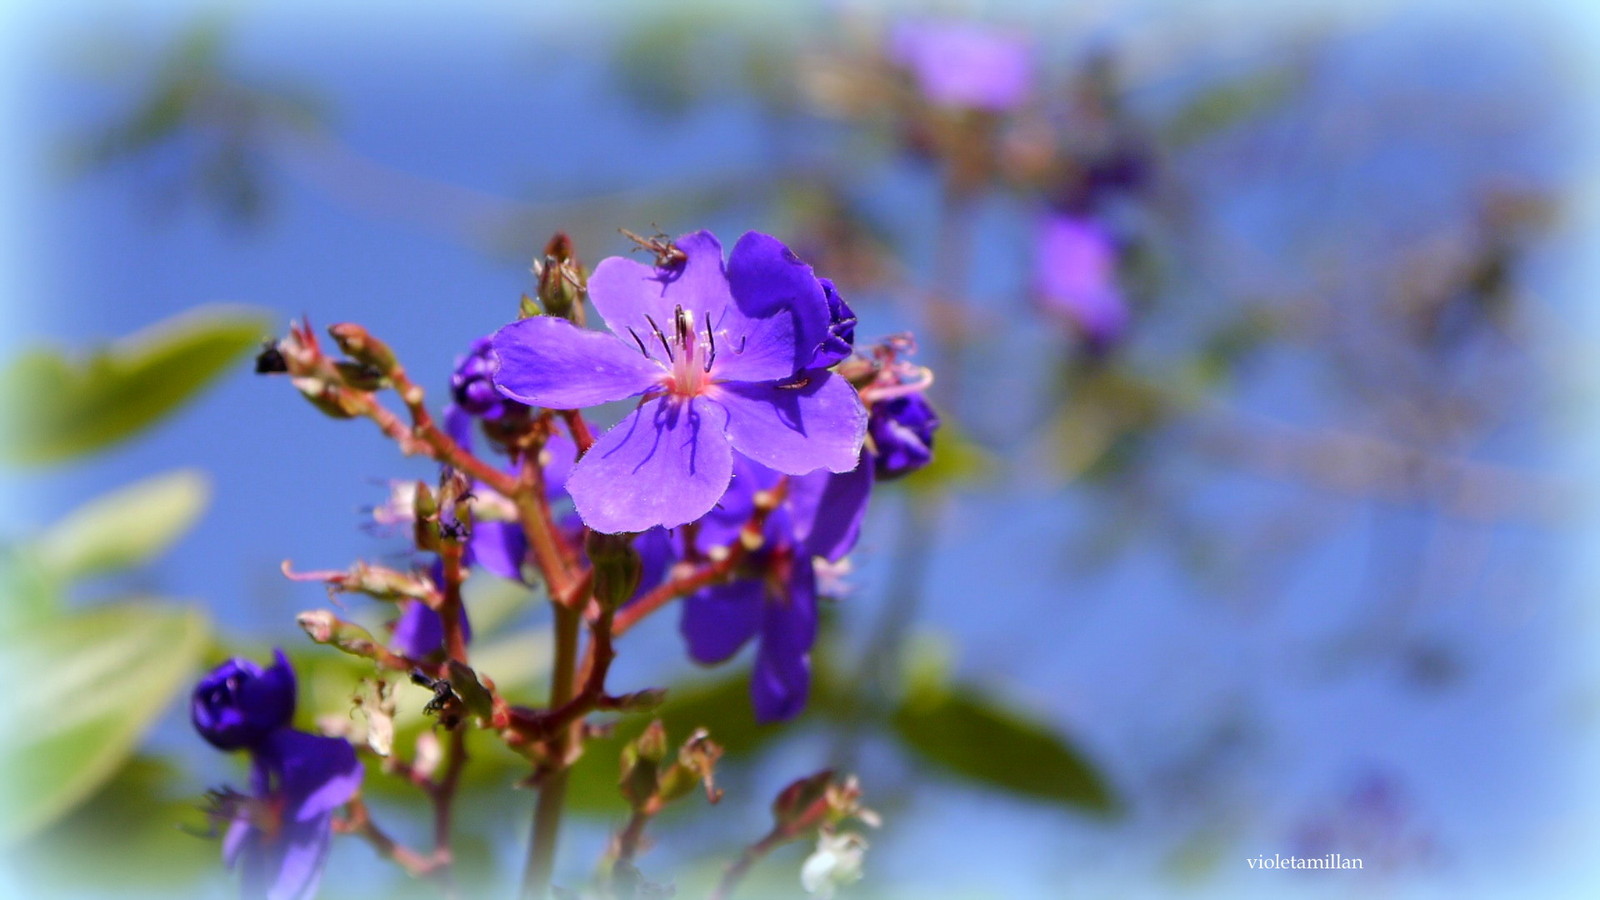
[216,224,939,898]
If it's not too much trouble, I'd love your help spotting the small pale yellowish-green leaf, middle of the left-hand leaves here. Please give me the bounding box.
[35,469,211,581]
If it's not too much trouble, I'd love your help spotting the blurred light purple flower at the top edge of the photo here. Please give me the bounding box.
[890,21,1034,112]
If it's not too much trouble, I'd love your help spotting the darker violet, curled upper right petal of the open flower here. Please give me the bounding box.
[712,231,832,381]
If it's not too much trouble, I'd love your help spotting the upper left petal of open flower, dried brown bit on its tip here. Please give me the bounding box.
[589,231,733,353]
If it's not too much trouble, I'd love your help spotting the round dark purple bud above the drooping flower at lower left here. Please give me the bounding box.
[189,650,294,749]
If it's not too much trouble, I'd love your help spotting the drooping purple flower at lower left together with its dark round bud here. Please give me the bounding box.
[190,650,362,900]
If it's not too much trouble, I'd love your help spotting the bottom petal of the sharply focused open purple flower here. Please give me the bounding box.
[566,399,733,533]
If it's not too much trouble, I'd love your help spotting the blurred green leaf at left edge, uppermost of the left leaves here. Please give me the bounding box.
[0,306,272,464]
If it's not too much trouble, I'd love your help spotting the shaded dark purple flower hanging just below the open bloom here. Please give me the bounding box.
[678,456,872,722]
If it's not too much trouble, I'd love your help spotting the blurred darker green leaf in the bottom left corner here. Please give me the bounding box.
[8,756,222,897]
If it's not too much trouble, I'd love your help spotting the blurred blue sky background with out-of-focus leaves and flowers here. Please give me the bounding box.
[0,0,1600,898]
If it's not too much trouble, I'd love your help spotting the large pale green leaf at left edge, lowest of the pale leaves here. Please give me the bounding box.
[0,601,208,842]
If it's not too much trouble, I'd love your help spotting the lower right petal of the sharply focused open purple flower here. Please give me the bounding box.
[714,372,867,476]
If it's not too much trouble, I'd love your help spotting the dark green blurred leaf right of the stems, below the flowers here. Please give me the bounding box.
[893,685,1117,814]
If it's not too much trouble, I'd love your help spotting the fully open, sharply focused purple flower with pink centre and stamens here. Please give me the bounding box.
[493,231,867,533]
